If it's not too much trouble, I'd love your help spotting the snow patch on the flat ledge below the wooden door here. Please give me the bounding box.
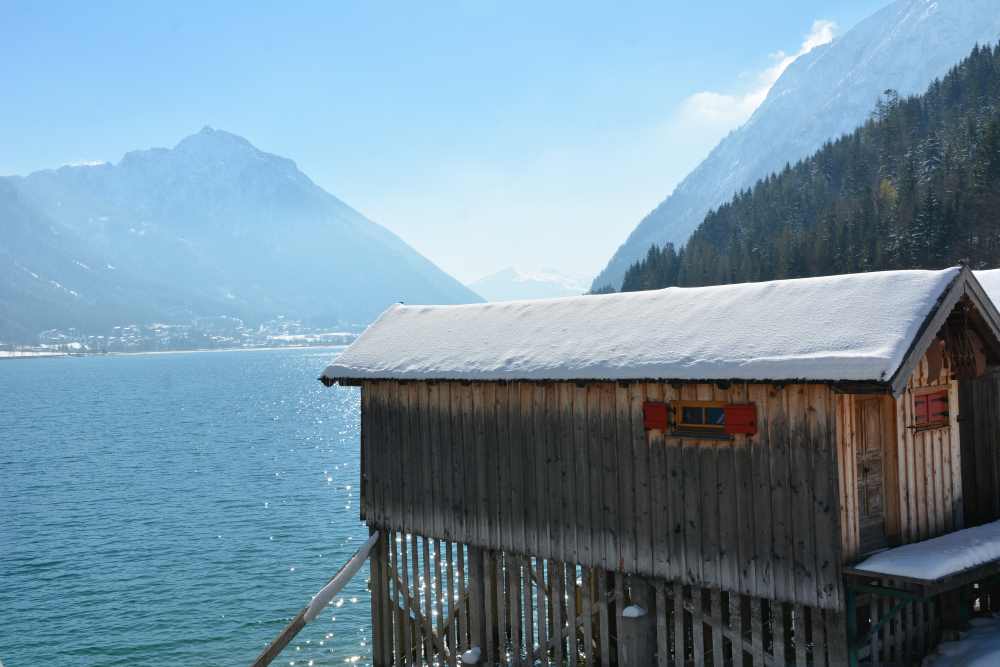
[854,521,1000,581]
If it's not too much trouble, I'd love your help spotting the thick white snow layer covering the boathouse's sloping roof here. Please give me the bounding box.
[324,268,959,381]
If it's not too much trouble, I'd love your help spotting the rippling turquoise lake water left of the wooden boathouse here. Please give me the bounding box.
[0,349,370,667]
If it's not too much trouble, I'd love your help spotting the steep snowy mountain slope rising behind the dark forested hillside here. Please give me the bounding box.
[593,0,1000,289]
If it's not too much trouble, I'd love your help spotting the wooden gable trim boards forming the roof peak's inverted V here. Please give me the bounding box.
[890,266,1000,398]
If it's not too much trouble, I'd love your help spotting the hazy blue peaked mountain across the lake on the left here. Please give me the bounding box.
[0,127,481,341]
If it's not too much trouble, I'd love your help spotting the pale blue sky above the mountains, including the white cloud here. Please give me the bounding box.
[0,0,887,282]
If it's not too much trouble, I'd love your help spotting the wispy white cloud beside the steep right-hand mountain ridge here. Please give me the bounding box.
[673,19,837,140]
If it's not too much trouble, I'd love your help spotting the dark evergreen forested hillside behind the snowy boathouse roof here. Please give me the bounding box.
[622,46,1000,291]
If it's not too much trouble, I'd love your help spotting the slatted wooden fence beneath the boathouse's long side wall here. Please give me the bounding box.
[371,531,846,667]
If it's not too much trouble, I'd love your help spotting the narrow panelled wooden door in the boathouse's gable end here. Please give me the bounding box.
[854,397,889,554]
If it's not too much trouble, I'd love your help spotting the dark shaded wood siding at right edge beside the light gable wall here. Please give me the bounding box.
[958,370,1000,526]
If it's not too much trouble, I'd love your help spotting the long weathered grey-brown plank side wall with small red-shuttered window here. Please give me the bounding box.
[362,382,842,609]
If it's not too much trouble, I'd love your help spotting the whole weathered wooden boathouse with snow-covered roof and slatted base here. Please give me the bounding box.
[321,268,1000,667]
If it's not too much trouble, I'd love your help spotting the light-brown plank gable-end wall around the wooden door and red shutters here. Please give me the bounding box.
[837,350,964,563]
